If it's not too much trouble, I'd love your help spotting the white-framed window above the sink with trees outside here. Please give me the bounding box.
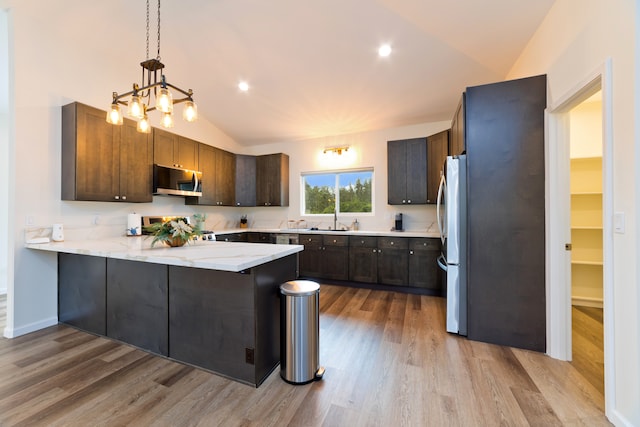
[301,169,373,215]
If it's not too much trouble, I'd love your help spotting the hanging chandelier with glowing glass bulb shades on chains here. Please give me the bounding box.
[107,0,198,133]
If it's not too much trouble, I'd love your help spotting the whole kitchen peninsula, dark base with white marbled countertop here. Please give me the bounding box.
[27,237,303,386]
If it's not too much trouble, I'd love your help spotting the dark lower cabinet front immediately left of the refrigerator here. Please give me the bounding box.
[409,238,442,295]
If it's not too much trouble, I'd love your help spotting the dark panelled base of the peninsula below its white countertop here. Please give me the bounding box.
[58,253,297,386]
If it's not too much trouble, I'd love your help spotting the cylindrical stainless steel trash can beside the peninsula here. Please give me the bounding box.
[280,280,324,384]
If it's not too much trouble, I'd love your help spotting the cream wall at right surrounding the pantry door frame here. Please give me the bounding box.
[508,0,640,426]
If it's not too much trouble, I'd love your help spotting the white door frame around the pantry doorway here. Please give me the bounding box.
[545,58,616,414]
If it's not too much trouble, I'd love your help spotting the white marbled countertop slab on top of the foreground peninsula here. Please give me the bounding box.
[26,236,304,272]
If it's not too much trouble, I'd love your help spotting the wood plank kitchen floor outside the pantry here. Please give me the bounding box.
[0,285,610,427]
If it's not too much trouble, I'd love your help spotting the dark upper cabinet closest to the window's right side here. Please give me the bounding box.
[387,138,427,205]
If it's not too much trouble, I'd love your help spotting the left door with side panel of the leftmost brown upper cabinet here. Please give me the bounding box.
[62,102,120,202]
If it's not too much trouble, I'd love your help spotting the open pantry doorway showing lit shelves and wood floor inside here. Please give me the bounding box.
[569,90,604,396]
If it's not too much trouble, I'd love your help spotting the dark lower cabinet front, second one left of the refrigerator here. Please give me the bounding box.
[378,237,409,286]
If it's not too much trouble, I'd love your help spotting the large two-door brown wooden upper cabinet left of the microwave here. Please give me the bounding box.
[62,102,153,202]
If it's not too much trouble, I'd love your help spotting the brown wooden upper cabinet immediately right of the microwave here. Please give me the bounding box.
[185,144,236,206]
